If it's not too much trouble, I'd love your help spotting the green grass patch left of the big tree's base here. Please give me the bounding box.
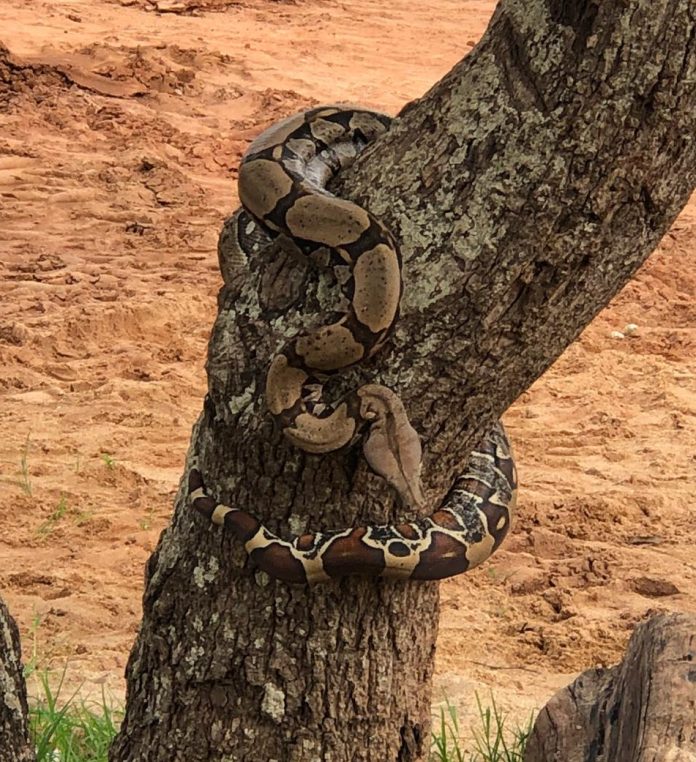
[29,669,121,762]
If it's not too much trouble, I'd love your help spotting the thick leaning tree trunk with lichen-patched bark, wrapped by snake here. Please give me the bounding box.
[110,0,696,762]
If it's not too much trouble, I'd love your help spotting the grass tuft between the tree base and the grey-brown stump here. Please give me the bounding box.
[430,694,533,762]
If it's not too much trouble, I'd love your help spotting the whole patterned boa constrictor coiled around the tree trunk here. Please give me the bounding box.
[189,106,517,582]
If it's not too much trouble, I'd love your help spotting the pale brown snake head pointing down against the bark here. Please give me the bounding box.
[358,384,425,508]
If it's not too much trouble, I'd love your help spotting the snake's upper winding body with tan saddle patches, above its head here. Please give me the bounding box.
[239,107,401,464]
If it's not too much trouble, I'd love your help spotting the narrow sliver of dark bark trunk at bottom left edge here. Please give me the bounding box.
[0,600,36,762]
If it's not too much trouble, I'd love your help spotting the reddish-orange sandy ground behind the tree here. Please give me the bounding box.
[0,0,696,744]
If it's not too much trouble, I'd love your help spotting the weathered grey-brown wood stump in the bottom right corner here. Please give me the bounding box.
[524,614,696,762]
